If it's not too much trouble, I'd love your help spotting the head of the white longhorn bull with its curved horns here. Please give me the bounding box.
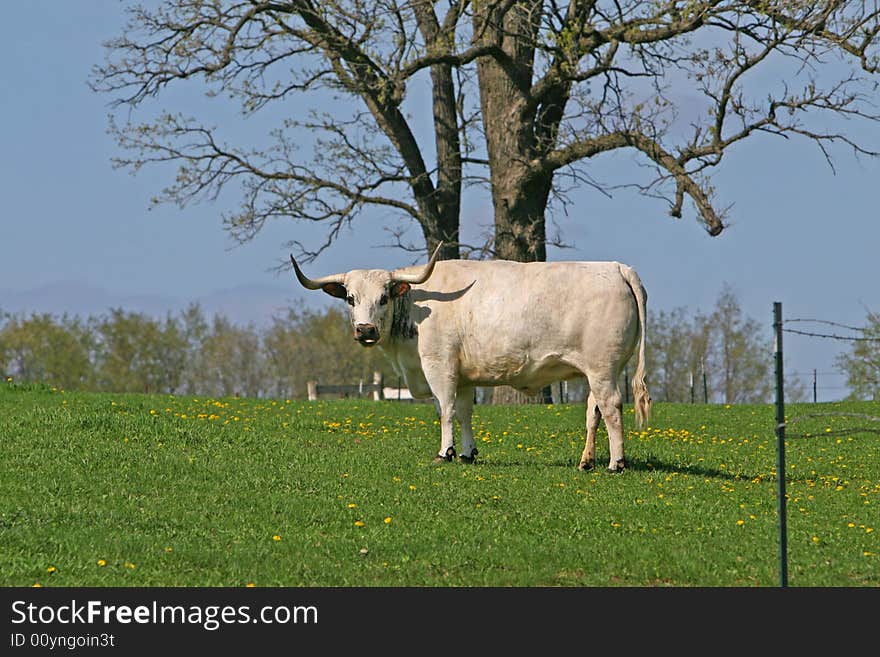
[290,243,442,347]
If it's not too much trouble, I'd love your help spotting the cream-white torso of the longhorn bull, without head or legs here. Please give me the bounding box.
[413,260,638,388]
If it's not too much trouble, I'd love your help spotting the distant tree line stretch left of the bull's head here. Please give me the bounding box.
[0,304,388,398]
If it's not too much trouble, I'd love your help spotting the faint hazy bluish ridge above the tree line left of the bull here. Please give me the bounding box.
[0,283,323,326]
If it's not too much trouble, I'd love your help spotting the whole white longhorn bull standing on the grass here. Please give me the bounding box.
[290,243,651,471]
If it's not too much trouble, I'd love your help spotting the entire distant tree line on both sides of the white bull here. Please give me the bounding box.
[0,287,880,404]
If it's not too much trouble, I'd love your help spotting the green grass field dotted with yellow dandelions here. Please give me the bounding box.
[0,382,880,587]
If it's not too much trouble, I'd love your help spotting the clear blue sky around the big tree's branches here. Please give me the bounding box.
[0,0,880,399]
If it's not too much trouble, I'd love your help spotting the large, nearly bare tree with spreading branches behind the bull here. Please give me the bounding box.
[91,0,880,260]
